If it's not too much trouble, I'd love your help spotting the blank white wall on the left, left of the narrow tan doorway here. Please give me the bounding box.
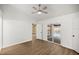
[3,8,33,47]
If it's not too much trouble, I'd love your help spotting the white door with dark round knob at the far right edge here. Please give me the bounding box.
[72,19,79,52]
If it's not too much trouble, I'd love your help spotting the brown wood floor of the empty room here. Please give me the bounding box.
[0,39,79,55]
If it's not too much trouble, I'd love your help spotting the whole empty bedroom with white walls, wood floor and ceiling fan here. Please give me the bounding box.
[0,4,79,55]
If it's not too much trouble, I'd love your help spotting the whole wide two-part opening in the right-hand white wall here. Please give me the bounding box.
[47,24,61,44]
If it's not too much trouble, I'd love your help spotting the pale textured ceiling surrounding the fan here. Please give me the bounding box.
[1,4,79,20]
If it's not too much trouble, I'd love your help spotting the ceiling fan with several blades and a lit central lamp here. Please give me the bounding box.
[32,4,48,14]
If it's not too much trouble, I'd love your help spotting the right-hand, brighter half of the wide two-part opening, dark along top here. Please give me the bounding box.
[52,24,61,44]
